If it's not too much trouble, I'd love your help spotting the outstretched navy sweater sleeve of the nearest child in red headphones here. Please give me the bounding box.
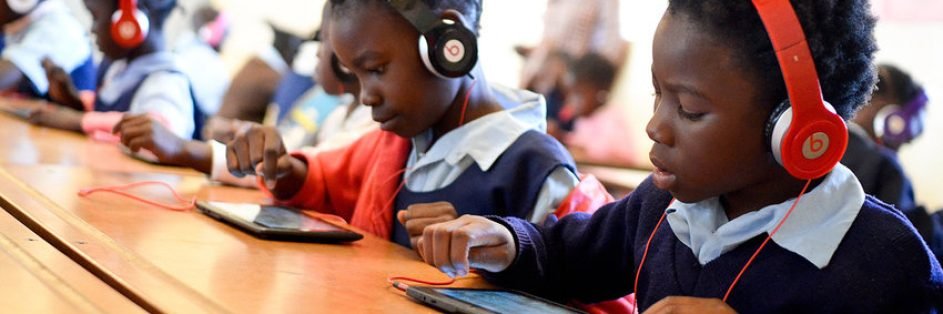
[481,181,670,303]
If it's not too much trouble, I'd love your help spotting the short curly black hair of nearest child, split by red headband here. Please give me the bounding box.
[668,0,877,119]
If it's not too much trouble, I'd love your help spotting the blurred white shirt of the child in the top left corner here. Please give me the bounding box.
[2,0,92,94]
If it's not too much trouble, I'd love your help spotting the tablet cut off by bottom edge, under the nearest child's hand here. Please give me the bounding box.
[406,286,585,314]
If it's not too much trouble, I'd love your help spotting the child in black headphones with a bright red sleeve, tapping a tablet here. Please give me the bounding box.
[227,0,577,246]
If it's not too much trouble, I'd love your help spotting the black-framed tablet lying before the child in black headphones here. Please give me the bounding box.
[196,201,363,243]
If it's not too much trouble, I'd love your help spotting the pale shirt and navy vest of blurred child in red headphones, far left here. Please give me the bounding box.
[82,51,205,139]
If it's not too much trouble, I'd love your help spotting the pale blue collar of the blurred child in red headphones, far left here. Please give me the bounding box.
[98,51,179,103]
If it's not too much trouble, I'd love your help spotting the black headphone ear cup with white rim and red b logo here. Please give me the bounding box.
[419,20,478,78]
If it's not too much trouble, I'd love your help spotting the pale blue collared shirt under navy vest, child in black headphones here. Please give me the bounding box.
[403,86,579,223]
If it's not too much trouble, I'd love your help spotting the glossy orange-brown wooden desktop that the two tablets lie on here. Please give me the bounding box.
[0,100,485,313]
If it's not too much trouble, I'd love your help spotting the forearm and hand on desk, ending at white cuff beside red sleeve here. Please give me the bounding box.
[113,114,213,174]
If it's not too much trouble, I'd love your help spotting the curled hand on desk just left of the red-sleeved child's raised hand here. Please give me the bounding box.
[113,114,188,166]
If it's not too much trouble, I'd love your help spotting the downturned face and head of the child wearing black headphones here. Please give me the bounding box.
[329,2,459,138]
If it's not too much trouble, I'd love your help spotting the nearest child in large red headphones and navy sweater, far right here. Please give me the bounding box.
[418,0,943,313]
